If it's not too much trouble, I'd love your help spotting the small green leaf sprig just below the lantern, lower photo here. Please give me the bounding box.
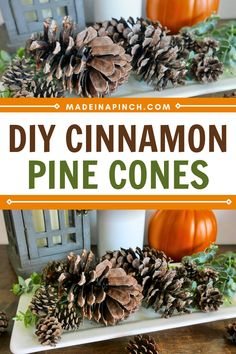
[11,273,41,296]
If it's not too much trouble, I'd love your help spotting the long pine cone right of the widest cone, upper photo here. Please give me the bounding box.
[95,18,187,90]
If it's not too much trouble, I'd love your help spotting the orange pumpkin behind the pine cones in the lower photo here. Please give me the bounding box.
[148,210,217,262]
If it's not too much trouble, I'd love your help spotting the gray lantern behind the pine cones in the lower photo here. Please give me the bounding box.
[3,210,90,276]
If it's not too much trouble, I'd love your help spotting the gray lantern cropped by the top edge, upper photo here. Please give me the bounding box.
[0,0,85,47]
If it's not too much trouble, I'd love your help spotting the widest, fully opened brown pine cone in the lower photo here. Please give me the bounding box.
[59,251,142,325]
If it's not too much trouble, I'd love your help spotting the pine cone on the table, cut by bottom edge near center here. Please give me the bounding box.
[127,335,160,354]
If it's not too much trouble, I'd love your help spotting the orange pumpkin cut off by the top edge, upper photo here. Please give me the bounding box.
[147,0,220,33]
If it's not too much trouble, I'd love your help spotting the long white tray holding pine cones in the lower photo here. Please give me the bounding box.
[10,295,236,354]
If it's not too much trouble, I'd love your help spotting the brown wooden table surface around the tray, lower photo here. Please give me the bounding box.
[0,246,236,354]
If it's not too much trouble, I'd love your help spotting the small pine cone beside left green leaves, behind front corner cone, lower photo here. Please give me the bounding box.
[29,285,58,317]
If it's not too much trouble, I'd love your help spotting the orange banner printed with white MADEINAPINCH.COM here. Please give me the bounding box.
[0,98,236,113]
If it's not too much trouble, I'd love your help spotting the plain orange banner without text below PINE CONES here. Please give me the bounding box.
[0,195,236,210]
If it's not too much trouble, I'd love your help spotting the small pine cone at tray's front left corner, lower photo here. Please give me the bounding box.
[35,316,62,347]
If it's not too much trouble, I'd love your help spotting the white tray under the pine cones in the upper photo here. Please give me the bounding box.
[112,70,236,98]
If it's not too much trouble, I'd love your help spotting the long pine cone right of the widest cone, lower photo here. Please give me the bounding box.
[102,247,193,317]
